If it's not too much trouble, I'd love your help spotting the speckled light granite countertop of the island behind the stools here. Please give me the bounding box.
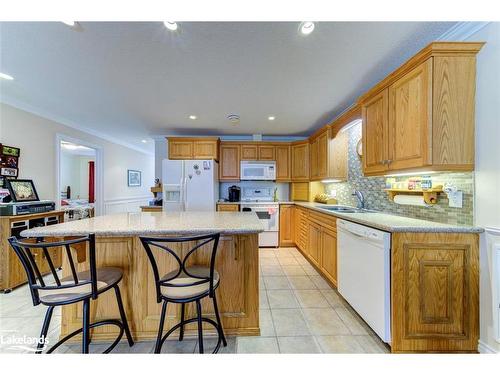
[21,211,264,237]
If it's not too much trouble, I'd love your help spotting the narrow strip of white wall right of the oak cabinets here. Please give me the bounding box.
[467,22,500,351]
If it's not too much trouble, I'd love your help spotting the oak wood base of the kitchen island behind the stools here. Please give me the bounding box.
[61,233,260,341]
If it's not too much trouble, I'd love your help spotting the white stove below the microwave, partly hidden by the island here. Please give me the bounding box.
[240,188,280,247]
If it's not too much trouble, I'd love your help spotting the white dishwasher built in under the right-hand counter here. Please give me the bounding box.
[337,220,391,343]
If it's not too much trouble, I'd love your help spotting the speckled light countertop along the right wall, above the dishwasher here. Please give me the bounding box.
[295,202,483,233]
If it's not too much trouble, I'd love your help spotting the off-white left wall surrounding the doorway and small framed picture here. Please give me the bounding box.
[0,104,154,212]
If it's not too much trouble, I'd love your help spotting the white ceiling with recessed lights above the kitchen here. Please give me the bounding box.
[0,22,454,151]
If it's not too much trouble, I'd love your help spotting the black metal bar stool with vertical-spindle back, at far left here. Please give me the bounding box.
[9,234,134,354]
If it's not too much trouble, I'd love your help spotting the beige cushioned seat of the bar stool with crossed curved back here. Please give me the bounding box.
[160,266,220,300]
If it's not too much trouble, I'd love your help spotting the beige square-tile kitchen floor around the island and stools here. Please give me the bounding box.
[0,248,389,353]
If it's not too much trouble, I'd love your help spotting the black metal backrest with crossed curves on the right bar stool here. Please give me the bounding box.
[139,233,220,302]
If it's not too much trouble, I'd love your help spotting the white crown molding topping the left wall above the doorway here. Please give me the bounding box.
[1,98,154,156]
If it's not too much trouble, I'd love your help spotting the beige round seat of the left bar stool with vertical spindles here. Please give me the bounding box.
[38,267,123,305]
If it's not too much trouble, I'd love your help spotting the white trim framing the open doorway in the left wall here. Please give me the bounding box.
[55,133,104,216]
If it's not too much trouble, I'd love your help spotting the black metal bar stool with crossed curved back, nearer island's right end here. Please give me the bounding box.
[140,233,227,353]
